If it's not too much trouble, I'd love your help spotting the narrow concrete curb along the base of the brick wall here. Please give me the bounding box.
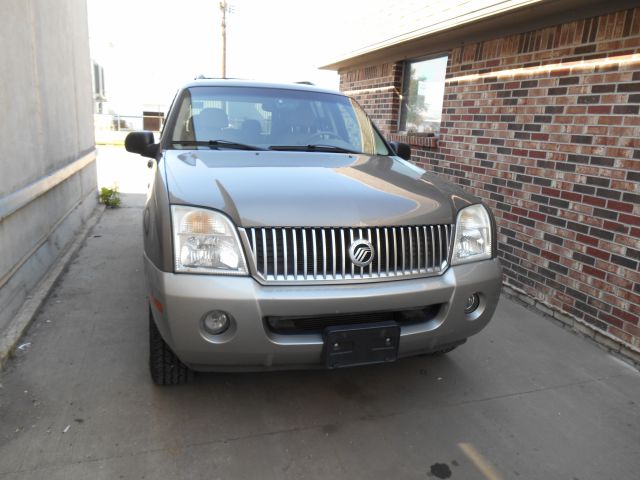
[502,284,640,369]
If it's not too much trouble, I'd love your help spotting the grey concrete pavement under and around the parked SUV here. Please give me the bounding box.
[0,147,640,480]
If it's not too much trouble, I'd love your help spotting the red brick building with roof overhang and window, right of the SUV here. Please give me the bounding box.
[324,0,640,362]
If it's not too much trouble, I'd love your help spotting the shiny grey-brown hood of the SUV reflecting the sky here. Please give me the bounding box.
[160,150,479,227]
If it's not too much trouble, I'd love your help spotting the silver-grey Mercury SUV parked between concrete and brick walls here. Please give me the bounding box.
[125,80,501,384]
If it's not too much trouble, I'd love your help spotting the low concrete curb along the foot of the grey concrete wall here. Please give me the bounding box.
[0,205,104,369]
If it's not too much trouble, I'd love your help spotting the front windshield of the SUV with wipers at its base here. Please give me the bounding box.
[166,86,389,155]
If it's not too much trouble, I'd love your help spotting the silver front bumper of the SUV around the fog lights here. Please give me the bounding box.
[145,256,502,371]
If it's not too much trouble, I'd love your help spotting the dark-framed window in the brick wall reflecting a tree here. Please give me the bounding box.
[398,56,447,136]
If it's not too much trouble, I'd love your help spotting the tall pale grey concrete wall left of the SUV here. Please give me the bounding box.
[0,0,97,335]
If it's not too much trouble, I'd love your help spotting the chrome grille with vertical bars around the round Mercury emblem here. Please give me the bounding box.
[240,225,453,282]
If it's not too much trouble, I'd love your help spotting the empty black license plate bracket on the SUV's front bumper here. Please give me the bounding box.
[323,321,400,369]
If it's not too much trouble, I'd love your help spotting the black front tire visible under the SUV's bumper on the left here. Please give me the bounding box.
[149,309,194,385]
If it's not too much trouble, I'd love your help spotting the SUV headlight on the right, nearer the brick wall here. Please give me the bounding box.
[451,205,493,265]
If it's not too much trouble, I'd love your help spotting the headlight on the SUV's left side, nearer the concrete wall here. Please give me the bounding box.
[171,205,247,275]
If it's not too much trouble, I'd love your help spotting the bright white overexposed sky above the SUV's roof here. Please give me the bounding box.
[87,0,370,115]
